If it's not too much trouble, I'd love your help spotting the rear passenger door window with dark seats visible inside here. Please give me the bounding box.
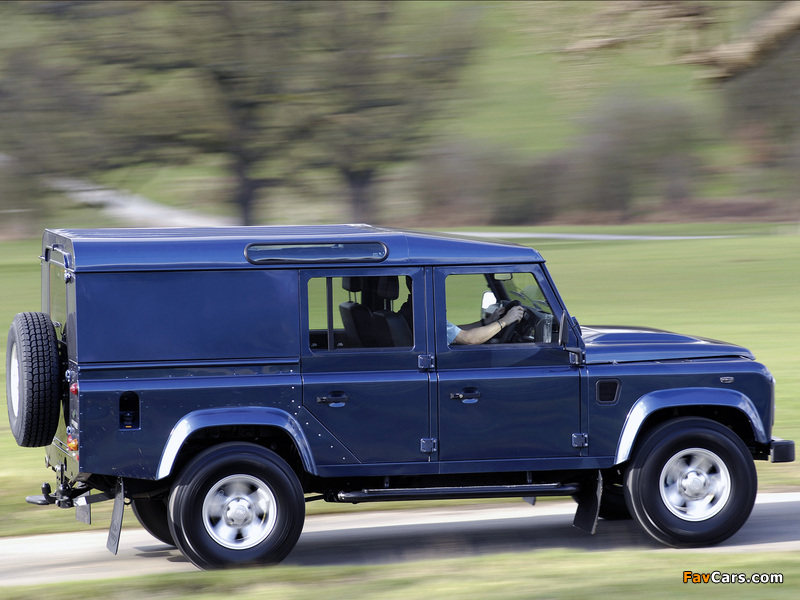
[308,275,414,350]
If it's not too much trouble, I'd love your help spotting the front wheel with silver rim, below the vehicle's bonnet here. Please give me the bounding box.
[625,417,758,548]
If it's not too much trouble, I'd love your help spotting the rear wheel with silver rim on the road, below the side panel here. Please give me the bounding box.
[169,442,305,569]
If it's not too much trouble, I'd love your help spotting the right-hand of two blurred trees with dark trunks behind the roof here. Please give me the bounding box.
[300,2,477,222]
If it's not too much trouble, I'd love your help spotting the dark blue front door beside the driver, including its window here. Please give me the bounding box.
[434,265,580,464]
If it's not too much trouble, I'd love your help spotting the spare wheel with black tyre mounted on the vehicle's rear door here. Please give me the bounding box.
[6,312,61,448]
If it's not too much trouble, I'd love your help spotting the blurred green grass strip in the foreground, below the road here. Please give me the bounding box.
[3,550,800,600]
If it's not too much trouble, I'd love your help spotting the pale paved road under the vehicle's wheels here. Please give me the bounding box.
[0,493,800,586]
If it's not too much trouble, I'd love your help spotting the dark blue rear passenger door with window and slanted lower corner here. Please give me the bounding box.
[300,268,431,463]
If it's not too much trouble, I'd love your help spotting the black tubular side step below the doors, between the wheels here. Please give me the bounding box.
[333,483,581,504]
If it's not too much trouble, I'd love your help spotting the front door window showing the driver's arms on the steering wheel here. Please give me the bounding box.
[445,272,558,345]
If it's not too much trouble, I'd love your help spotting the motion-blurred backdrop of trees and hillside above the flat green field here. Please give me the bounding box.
[0,0,800,238]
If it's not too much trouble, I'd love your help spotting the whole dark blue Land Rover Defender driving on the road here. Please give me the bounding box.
[6,225,794,568]
